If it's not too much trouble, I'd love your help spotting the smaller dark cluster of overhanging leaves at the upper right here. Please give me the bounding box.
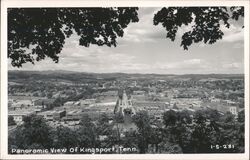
[154,7,244,50]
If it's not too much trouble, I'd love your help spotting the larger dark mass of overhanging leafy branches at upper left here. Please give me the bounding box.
[8,7,138,67]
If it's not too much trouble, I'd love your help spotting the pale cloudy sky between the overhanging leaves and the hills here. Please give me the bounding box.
[8,7,244,74]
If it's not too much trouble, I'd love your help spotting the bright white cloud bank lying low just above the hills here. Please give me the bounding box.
[9,53,244,74]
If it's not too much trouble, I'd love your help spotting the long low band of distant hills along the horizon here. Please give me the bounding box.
[8,70,244,82]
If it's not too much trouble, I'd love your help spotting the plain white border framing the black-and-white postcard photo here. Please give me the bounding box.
[0,0,249,160]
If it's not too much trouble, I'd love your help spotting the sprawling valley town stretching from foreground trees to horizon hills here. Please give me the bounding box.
[8,71,244,152]
